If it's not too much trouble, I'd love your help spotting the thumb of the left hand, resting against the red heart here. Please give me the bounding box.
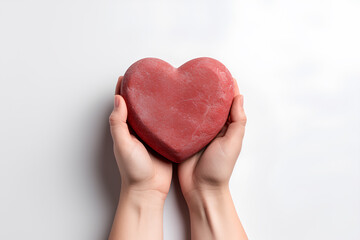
[109,94,131,146]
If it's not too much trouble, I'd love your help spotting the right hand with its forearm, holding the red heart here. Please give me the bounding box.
[178,80,247,240]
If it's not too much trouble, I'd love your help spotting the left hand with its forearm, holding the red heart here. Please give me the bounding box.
[109,77,172,240]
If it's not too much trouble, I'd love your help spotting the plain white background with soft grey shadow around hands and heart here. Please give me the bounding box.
[0,0,360,240]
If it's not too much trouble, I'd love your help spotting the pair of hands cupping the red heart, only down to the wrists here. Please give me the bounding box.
[109,77,246,204]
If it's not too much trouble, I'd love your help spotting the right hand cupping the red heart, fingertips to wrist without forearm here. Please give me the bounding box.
[178,79,246,201]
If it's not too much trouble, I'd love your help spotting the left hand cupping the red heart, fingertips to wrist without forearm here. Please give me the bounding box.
[109,77,172,199]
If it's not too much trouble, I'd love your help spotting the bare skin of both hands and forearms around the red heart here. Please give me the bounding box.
[109,77,247,240]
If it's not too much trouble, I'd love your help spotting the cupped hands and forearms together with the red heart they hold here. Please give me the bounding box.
[109,58,247,239]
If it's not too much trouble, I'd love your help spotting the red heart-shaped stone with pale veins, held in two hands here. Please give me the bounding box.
[120,57,234,163]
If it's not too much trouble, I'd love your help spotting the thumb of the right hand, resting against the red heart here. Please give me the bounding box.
[224,95,247,143]
